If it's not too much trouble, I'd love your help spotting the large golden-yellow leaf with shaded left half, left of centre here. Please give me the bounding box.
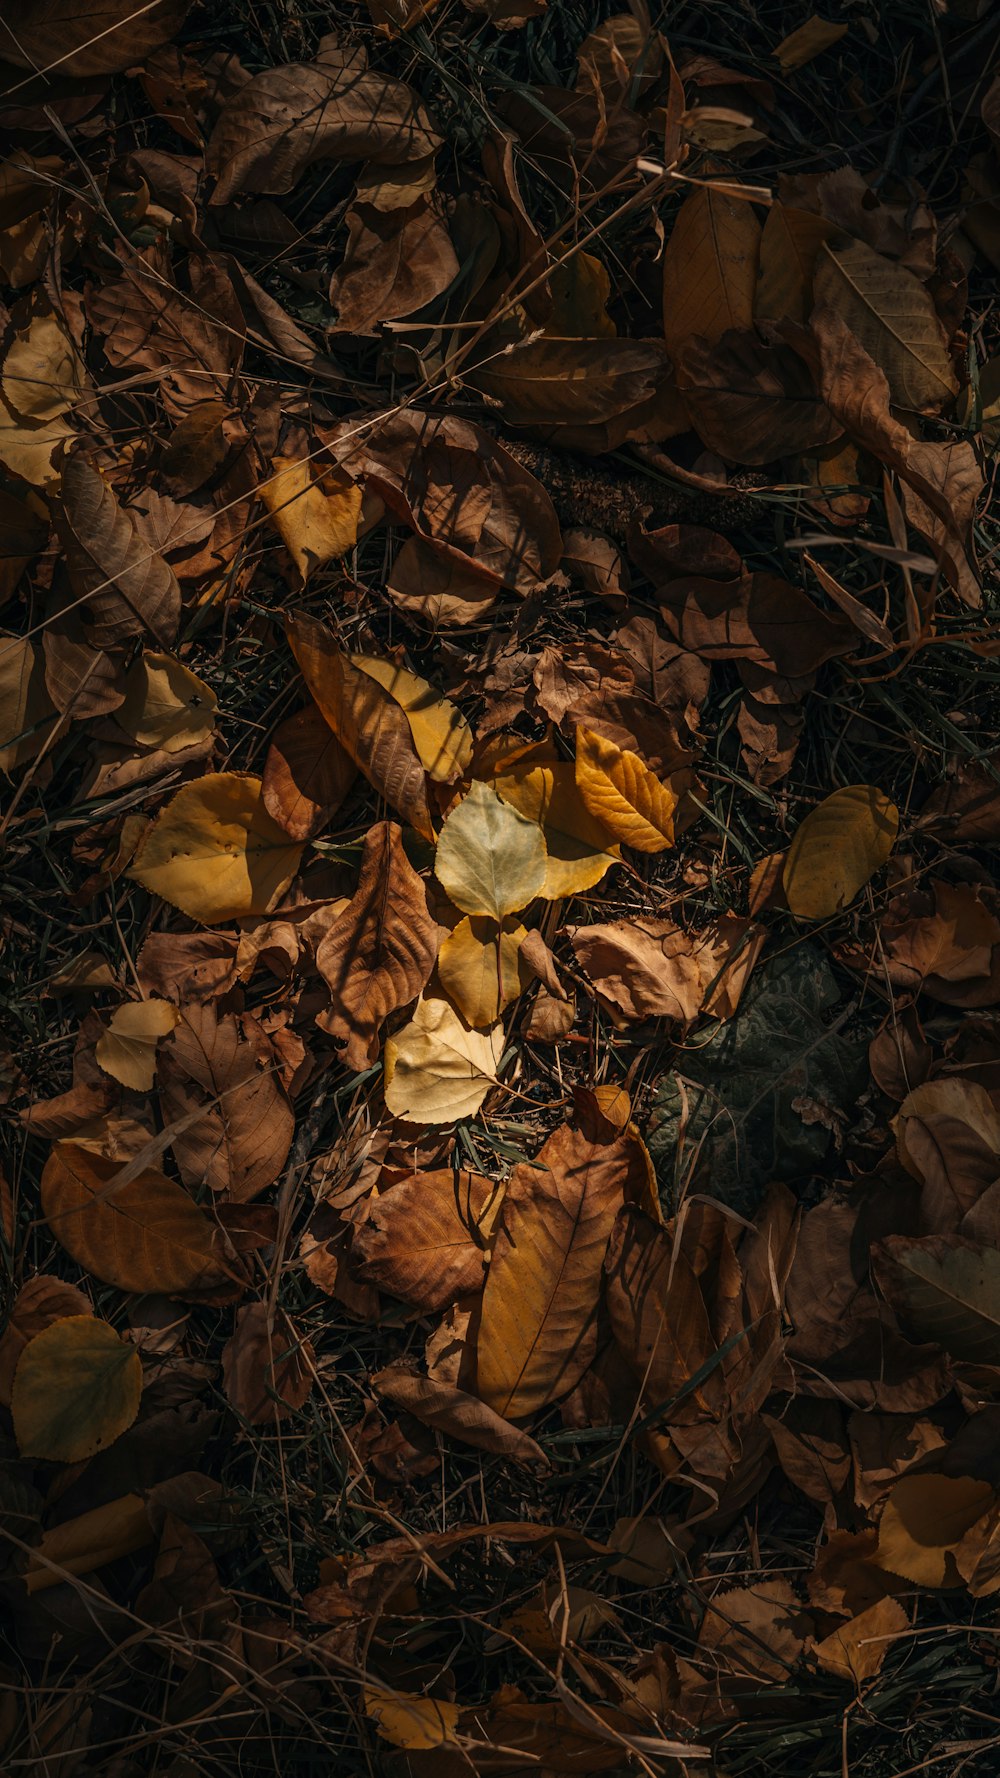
[128,772,302,926]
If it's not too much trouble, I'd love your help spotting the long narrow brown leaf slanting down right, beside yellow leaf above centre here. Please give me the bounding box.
[286,617,434,839]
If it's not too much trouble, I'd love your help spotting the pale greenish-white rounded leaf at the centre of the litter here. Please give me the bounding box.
[434,781,546,921]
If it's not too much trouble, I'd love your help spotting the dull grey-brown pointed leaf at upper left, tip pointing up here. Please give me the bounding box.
[55,457,180,649]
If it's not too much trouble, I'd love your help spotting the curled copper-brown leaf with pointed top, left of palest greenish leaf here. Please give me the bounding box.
[317,821,438,1072]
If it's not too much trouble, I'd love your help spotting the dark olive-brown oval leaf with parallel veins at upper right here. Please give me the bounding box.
[815,238,959,412]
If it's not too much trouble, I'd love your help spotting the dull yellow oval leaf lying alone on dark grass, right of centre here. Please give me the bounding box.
[781,784,899,919]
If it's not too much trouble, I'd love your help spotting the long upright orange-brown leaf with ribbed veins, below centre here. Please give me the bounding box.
[477,1124,639,1419]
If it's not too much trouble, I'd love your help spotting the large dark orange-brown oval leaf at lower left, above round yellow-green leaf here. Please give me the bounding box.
[41,1141,231,1296]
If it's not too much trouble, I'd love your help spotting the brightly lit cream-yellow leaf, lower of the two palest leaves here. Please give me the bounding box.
[384,999,504,1124]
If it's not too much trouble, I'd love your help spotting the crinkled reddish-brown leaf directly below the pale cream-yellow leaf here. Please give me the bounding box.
[351,1166,495,1312]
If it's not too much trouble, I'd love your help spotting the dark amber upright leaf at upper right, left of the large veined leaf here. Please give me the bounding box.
[664,185,760,356]
